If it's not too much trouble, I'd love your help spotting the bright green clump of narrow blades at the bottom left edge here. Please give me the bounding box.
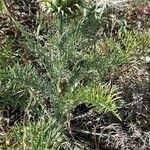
[1,118,66,150]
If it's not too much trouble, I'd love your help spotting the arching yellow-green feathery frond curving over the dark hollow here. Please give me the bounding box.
[58,84,121,120]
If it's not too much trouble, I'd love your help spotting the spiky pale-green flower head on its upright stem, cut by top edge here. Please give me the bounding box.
[40,0,85,43]
